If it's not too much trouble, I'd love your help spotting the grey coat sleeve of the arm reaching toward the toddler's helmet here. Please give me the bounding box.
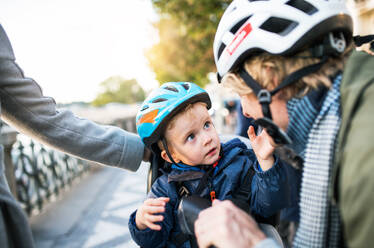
[0,25,144,171]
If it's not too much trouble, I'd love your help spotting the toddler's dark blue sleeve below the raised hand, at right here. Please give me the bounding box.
[250,157,290,217]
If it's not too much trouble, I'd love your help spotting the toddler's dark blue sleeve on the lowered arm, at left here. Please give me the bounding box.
[129,175,176,248]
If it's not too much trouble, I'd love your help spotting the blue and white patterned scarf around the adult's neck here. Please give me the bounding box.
[288,74,342,248]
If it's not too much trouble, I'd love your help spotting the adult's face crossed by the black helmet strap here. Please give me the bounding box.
[240,93,288,131]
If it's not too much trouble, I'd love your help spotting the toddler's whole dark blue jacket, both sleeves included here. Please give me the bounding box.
[129,139,289,248]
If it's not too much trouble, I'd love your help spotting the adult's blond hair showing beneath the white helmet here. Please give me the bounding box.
[222,52,345,100]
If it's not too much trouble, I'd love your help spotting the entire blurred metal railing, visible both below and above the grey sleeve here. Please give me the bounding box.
[0,111,135,215]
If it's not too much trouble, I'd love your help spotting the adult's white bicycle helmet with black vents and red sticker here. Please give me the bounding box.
[213,0,353,78]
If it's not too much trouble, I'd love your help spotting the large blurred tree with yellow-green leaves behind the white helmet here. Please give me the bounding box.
[146,0,231,86]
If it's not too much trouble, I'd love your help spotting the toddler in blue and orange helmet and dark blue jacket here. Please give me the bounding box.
[129,82,288,248]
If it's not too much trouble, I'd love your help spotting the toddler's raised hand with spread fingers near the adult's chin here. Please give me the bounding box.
[247,126,275,171]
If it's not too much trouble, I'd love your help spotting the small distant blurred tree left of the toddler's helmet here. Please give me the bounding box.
[91,76,145,106]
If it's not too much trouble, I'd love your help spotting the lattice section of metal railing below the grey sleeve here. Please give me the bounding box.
[12,140,89,215]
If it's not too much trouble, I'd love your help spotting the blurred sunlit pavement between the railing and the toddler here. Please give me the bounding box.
[30,164,148,248]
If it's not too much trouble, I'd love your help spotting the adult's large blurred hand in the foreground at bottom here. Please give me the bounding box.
[195,200,266,248]
